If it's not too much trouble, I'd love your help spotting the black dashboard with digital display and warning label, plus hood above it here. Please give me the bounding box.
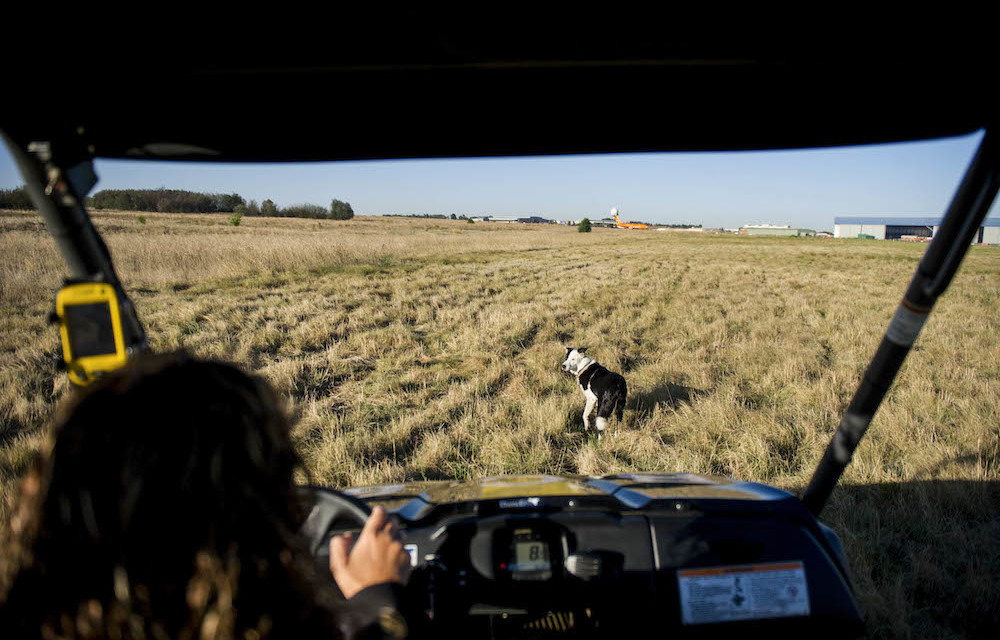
[308,474,863,638]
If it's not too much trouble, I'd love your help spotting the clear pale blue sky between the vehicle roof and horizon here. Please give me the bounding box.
[0,133,997,230]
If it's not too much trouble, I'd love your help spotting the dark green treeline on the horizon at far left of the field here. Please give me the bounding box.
[0,186,354,220]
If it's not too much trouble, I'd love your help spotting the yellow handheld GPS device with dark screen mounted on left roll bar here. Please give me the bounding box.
[56,282,128,386]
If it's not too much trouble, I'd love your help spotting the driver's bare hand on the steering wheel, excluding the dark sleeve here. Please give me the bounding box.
[330,507,410,598]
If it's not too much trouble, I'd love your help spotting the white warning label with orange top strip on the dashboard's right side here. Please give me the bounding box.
[677,562,809,624]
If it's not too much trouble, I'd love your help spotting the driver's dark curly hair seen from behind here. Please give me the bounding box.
[0,354,339,639]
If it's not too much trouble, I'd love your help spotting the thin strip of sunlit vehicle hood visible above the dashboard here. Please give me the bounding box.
[345,473,793,509]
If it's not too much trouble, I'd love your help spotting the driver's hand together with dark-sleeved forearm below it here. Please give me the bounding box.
[330,506,410,640]
